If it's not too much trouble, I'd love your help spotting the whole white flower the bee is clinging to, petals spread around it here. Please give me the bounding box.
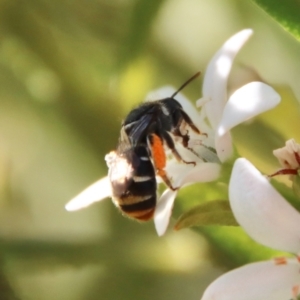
[66,29,280,235]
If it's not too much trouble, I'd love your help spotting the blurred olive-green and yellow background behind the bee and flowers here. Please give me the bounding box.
[0,0,300,300]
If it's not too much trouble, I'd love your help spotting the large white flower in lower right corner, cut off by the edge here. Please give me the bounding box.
[202,158,300,300]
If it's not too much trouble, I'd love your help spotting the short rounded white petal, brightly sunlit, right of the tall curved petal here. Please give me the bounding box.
[217,82,280,136]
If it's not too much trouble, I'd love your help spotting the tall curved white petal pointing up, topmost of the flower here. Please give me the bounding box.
[202,29,253,129]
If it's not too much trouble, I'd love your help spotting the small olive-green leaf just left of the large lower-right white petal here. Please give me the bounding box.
[175,200,238,230]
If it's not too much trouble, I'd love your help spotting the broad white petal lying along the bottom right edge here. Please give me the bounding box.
[202,261,300,300]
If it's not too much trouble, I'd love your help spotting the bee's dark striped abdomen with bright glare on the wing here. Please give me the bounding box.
[105,128,157,221]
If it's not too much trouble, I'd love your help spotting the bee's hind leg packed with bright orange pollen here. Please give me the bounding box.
[148,134,178,191]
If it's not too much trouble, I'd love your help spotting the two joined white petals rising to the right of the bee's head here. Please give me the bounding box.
[197,29,280,162]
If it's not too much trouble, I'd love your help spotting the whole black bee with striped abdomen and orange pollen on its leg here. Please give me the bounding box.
[106,72,205,221]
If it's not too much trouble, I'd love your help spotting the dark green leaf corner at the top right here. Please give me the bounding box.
[252,0,300,40]
